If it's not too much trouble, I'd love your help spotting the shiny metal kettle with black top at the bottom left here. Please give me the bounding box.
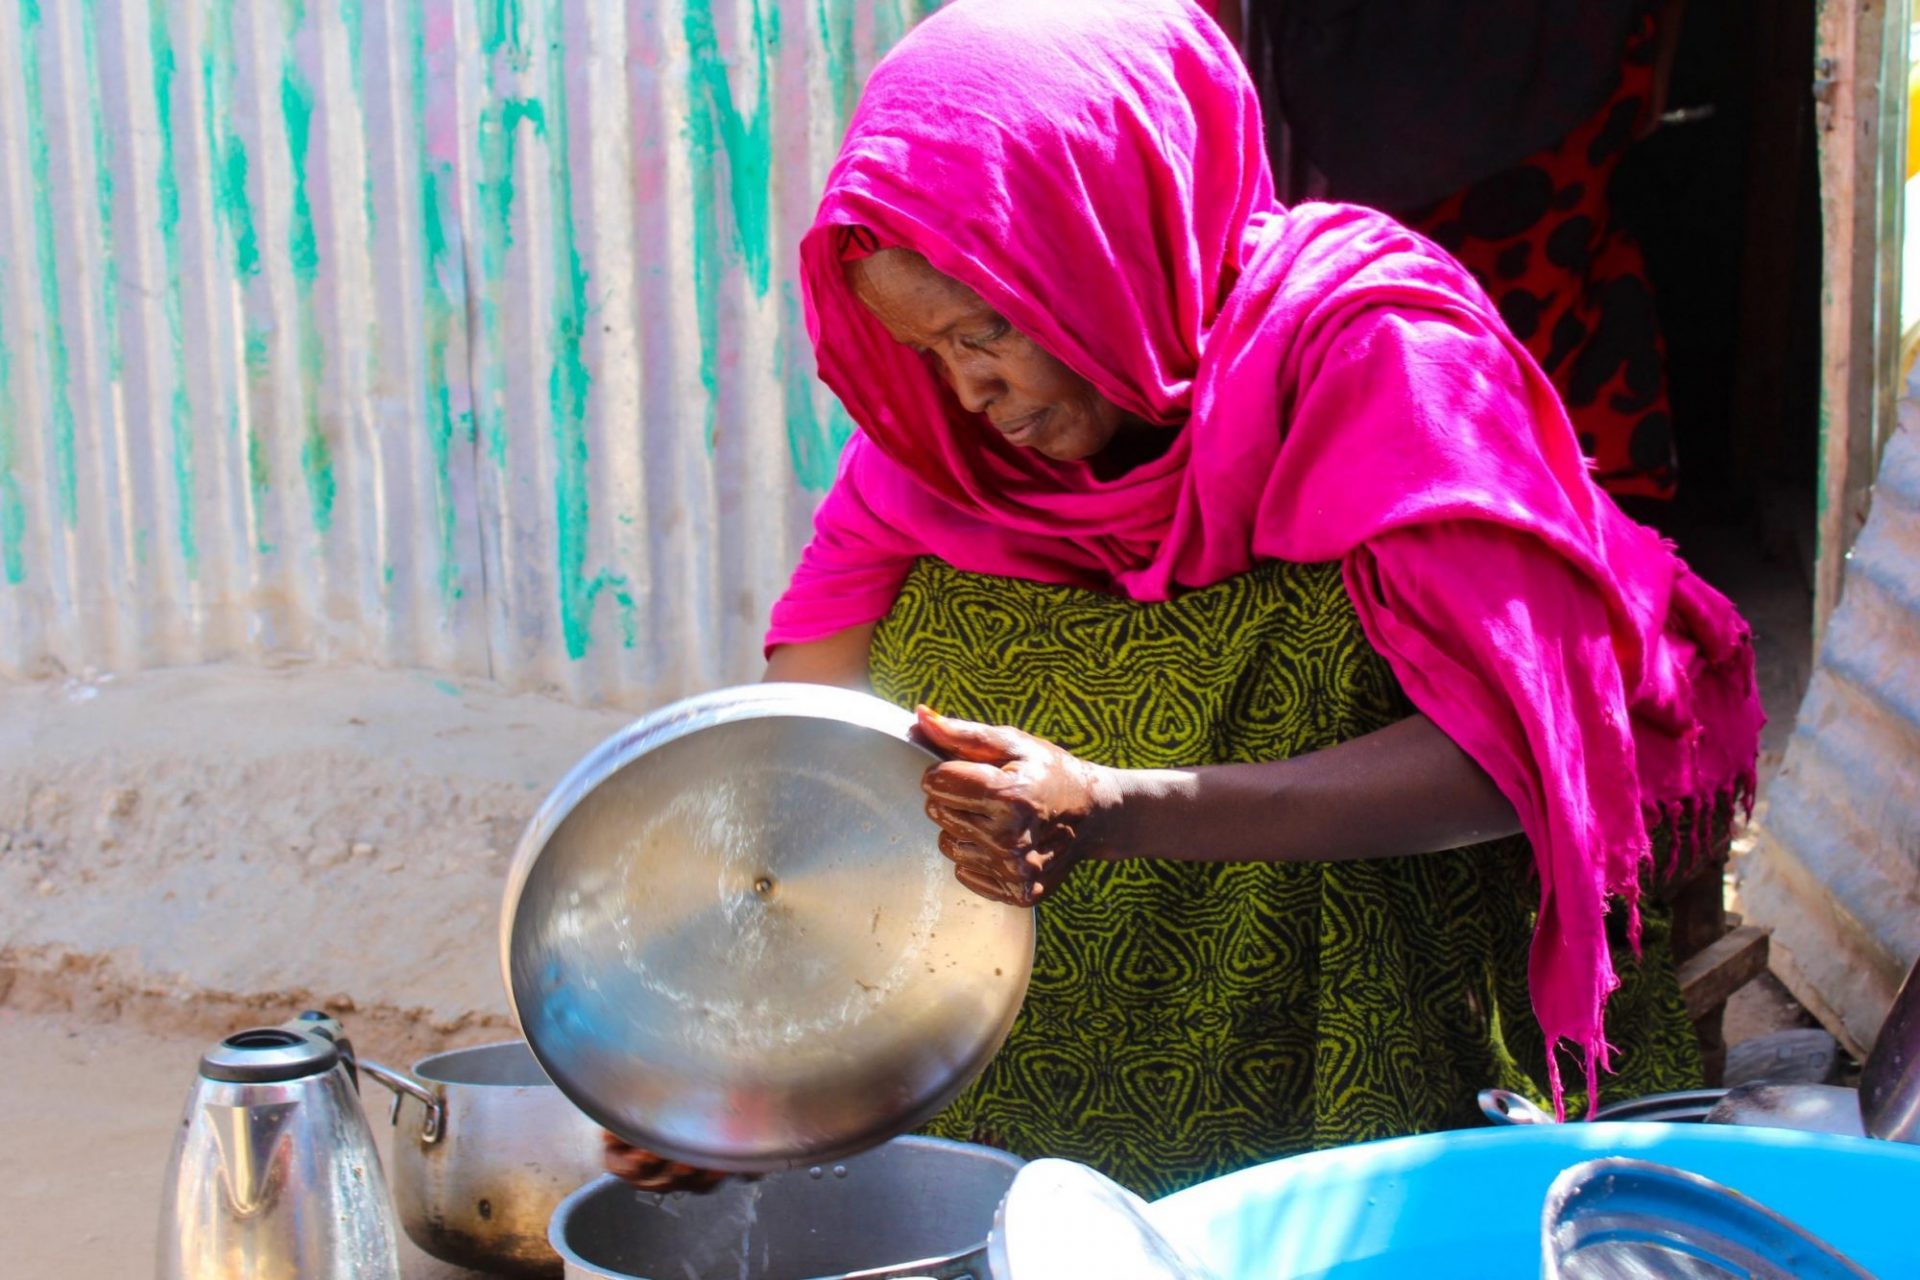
[156,1013,399,1280]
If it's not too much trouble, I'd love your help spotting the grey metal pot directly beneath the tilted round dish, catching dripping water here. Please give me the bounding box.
[549,1136,1021,1280]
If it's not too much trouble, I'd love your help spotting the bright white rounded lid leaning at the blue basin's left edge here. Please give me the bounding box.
[987,1159,1213,1280]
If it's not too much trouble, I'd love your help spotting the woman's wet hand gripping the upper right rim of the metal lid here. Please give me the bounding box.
[918,706,1121,906]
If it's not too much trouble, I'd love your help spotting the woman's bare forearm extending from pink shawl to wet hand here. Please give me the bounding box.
[1092,716,1521,862]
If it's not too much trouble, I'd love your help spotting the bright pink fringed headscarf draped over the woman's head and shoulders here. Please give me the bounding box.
[768,0,1761,1103]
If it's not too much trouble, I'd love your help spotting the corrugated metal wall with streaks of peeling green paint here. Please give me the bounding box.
[0,0,937,706]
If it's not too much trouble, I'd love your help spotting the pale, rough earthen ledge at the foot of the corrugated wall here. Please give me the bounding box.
[0,666,630,1046]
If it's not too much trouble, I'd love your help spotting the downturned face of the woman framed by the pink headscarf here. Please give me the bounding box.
[847,249,1135,462]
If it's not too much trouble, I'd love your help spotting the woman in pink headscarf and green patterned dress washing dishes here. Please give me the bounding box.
[614,0,1759,1194]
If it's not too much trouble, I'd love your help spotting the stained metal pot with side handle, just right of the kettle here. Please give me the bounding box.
[359,1040,603,1276]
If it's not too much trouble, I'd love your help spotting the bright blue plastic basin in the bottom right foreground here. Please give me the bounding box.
[1154,1123,1920,1280]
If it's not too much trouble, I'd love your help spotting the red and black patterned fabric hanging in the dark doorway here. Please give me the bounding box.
[1402,19,1676,497]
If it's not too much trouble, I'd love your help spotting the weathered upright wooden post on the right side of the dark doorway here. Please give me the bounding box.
[1812,0,1908,643]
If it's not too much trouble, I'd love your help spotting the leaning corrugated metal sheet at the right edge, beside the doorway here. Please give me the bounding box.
[1740,399,1920,1052]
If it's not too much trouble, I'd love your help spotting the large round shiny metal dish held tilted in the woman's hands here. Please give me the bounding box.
[501,685,1033,1171]
